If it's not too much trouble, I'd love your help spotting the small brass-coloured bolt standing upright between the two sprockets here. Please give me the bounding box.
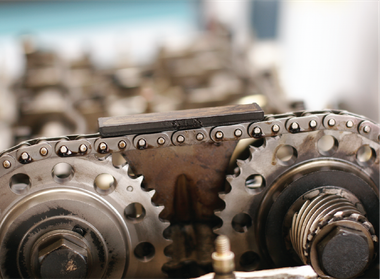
[211,235,235,278]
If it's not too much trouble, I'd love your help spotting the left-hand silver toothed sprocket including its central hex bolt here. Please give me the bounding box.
[0,153,170,279]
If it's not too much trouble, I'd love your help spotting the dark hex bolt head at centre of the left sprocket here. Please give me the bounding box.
[38,238,88,279]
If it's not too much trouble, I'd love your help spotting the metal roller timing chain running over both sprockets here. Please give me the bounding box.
[0,110,380,176]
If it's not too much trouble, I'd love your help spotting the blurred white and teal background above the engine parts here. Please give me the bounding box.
[0,0,380,149]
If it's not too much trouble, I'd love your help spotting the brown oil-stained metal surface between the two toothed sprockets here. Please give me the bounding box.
[125,142,236,276]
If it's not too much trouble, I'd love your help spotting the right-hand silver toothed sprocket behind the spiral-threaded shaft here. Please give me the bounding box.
[215,122,380,276]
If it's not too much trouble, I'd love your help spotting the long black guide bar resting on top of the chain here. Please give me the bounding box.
[98,103,264,137]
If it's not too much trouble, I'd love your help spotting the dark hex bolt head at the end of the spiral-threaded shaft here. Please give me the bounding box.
[317,226,371,278]
